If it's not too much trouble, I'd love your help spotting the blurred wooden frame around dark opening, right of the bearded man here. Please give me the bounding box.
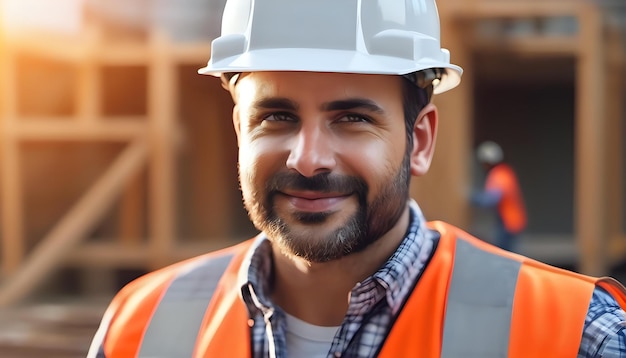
[428,0,626,276]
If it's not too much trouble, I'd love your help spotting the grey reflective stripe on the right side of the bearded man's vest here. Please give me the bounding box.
[441,240,521,358]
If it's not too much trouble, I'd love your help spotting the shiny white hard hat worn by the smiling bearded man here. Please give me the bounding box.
[198,0,463,93]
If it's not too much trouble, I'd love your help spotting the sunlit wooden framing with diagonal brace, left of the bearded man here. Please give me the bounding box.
[0,28,234,306]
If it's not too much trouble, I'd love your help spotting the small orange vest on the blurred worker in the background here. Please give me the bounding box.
[485,163,527,233]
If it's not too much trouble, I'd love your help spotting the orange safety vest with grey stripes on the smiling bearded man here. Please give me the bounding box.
[89,222,626,358]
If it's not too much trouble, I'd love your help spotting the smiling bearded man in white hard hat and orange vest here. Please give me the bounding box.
[89,0,626,358]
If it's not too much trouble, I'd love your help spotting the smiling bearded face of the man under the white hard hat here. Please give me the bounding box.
[233,72,410,262]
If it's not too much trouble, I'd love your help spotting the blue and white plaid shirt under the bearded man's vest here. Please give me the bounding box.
[240,200,626,358]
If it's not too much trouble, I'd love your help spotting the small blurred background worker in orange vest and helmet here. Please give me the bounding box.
[471,141,527,251]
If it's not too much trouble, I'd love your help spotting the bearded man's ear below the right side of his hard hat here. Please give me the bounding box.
[411,103,438,176]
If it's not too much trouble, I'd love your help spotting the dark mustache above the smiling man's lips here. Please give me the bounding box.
[266,172,367,193]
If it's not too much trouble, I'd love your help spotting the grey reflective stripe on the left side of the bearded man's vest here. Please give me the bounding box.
[137,254,233,358]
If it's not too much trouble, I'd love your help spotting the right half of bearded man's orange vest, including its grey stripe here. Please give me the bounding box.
[380,222,597,358]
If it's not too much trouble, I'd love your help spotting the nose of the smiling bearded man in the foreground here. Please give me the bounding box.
[287,126,336,177]
